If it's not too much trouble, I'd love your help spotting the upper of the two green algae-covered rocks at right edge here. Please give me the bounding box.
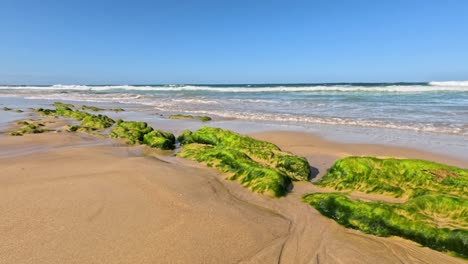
[318,157,468,197]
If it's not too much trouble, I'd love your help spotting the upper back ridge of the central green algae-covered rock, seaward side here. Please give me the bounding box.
[178,127,310,181]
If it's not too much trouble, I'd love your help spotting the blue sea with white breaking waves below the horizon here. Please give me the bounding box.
[0,82,468,136]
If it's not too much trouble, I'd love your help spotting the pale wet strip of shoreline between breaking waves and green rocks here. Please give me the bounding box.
[0,97,468,160]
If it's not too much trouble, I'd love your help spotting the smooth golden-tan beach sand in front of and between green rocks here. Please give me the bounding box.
[0,132,466,264]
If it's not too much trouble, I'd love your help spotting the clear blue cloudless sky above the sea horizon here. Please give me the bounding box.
[0,0,468,84]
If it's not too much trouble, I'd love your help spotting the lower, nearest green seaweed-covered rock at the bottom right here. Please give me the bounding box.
[303,193,468,256]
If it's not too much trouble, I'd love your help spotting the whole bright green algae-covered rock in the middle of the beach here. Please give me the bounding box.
[177,127,310,197]
